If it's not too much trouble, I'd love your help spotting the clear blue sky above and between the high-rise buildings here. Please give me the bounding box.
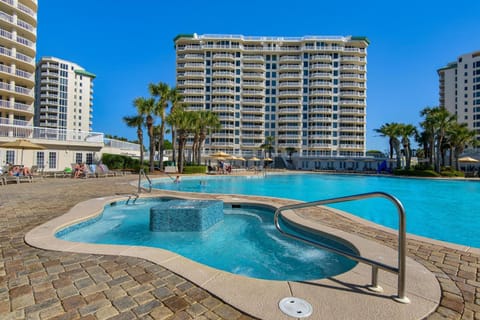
[37,0,480,151]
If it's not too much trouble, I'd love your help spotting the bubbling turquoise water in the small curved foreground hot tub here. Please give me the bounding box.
[56,199,356,281]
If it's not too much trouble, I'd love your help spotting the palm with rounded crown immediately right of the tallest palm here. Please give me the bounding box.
[165,108,194,172]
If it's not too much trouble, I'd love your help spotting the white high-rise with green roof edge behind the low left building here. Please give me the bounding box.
[35,57,95,132]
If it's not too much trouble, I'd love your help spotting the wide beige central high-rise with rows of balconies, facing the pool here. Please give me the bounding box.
[174,34,369,159]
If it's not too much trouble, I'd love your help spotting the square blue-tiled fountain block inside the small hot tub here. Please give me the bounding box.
[150,200,223,232]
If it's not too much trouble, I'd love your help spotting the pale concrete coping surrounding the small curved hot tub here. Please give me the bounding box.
[25,192,440,319]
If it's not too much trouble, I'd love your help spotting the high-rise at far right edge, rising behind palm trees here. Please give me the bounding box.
[438,51,480,140]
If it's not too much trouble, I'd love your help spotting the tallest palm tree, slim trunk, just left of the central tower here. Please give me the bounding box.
[152,82,170,170]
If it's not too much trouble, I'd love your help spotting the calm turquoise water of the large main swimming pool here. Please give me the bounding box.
[154,174,480,248]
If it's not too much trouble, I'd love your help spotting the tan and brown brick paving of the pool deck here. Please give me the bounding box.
[0,176,480,320]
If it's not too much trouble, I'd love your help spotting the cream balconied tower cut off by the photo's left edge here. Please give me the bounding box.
[0,0,37,129]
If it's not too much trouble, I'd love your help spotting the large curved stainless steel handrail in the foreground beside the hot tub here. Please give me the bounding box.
[274,192,410,303]
